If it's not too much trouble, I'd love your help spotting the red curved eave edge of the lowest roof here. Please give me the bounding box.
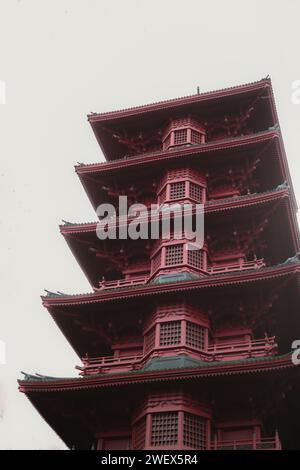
[18,354,297,394]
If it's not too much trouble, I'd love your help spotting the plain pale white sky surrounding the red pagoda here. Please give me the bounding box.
[0,0,300,449]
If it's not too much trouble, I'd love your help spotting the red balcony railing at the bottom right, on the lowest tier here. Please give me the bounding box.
[211,436,281,450]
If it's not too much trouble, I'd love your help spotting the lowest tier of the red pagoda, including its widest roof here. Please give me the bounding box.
[19,354,300,450]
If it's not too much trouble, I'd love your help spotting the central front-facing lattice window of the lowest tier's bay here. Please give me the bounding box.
[151,412,178,446]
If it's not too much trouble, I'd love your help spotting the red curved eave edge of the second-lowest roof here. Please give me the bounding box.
[42,262,300,309]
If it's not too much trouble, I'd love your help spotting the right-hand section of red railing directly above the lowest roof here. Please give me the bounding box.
[208,336,277,360]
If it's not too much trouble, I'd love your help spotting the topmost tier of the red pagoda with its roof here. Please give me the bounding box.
[88,78,278,160]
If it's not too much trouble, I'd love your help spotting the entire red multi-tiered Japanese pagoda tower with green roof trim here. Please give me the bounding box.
[19,79,300,450]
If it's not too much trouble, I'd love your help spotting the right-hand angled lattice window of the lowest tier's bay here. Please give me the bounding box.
[183,413,207,450]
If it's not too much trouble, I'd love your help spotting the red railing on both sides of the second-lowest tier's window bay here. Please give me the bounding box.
[76,337,277,375]
